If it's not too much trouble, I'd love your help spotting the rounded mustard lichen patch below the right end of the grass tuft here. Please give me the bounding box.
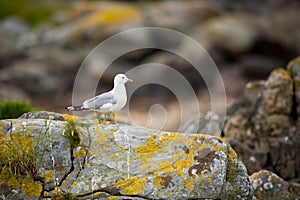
[22,176,43,198]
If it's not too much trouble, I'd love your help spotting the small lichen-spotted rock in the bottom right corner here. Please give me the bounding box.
[250,170,300,200]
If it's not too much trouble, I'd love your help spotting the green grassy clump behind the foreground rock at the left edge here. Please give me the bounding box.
[0,100,37,119]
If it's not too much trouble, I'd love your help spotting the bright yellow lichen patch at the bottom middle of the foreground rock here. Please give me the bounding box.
[115,176,148,195]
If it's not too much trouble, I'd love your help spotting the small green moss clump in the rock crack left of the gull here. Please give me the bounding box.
[64,120,80,149]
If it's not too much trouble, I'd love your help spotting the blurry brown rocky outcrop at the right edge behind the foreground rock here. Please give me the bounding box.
[224,59,300,181]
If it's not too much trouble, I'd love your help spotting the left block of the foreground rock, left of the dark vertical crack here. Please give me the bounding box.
[0,112,72,199]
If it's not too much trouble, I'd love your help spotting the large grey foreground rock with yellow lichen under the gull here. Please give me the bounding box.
[0,112,252,199]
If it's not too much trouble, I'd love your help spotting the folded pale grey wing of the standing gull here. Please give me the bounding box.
[83,92,117,109]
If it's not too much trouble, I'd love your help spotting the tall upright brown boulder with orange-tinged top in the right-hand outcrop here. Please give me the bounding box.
[252,69,293,137]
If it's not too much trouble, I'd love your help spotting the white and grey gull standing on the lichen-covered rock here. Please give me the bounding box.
[66,74,133,123]
